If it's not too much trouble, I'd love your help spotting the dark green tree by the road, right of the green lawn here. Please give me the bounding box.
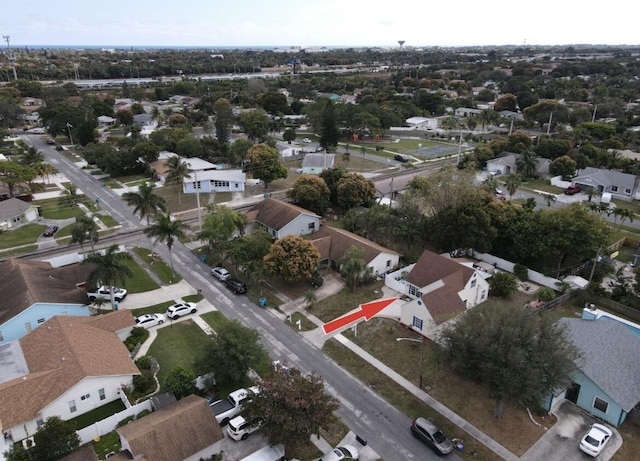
[196,320,268,388]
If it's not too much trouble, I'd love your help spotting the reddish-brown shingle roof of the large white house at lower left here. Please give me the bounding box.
[0,309,140,427]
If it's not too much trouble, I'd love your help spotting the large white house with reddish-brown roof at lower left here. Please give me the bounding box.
[0,310,140,442]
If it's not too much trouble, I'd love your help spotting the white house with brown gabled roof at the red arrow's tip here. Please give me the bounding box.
[385,251,489,337]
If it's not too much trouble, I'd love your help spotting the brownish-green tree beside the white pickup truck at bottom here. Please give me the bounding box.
[243,368,339,446]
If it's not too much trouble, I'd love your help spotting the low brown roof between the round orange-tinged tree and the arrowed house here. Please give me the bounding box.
[311,226,399,264]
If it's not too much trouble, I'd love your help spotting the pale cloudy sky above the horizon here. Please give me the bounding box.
[0,0,640,48]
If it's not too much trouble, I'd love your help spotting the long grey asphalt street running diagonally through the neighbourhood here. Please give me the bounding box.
[22,135,460,461]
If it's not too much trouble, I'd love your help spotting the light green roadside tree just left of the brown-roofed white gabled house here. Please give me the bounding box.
[198,205,247,260]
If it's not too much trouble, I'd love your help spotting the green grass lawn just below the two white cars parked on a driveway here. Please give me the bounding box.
[148,320,211,392]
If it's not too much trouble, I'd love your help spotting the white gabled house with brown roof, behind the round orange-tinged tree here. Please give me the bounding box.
[246,198,320,239]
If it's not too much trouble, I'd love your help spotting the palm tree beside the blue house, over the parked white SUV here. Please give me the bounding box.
[81,245,133,306]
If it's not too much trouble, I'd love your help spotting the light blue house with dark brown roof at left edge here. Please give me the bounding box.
[0,259,91,344]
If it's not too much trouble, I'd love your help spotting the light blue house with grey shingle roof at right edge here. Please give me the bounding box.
[545,318,640,427]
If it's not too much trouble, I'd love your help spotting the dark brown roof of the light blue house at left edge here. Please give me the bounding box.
[0,259,89,325]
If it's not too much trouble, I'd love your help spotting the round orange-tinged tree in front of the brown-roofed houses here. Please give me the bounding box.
[264,235,320,283]
